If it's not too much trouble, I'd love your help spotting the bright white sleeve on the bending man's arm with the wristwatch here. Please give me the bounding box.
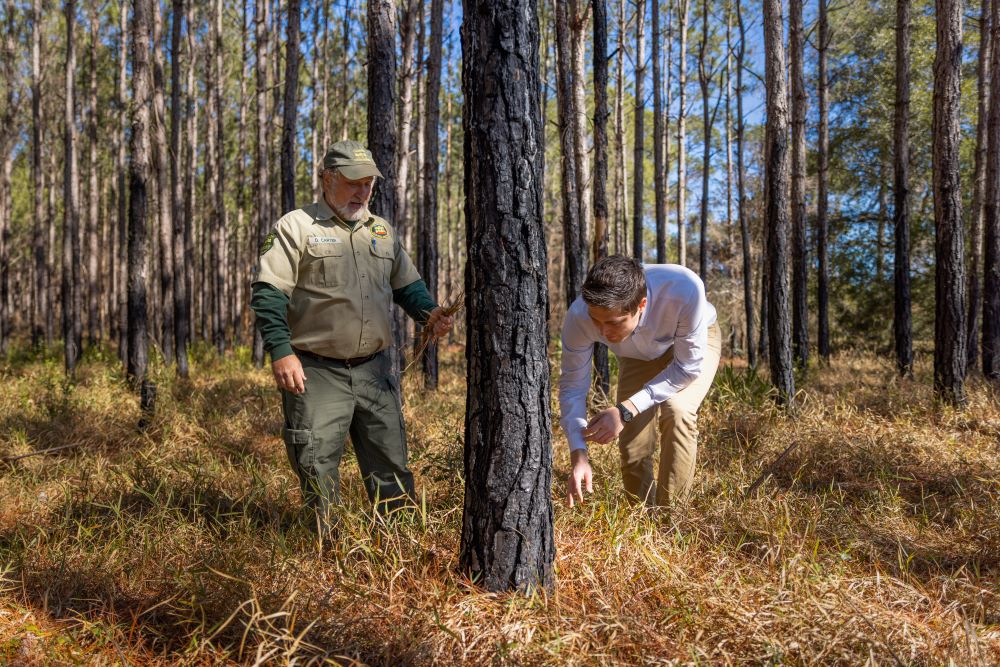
[629,281,712,412]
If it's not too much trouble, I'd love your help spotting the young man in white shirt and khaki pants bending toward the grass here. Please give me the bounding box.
[559,255,722,507]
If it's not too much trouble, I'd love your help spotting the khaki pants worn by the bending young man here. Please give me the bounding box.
[618,324,722,505]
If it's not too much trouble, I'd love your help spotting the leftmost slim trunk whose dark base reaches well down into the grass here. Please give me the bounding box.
[62,0,80,378]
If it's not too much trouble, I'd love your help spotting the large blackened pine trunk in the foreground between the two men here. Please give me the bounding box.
[459,0,555,592]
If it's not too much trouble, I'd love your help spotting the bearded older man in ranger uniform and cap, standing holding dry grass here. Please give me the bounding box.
[251,141,452,526]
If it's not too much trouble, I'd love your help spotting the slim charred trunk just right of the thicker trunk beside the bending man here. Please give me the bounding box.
[788,0,809,368]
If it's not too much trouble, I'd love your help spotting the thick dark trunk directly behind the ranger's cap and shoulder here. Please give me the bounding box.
[368,0,406,378]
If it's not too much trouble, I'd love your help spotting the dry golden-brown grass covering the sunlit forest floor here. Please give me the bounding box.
[0,347,1000,665]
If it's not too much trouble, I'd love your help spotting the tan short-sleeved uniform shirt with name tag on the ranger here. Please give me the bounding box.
[254,200,420,359]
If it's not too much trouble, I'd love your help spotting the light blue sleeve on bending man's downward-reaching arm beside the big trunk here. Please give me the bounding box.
[559,309,594,452]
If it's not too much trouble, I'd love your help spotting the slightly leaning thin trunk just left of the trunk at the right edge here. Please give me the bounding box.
[966,0,993,371]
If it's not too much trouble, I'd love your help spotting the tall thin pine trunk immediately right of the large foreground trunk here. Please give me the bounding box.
[555,2,585,307]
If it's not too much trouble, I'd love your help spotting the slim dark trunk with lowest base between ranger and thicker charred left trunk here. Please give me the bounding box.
[170,0,188,378]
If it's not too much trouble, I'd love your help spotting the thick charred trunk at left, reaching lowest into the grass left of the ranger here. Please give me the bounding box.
[127,0,152,386]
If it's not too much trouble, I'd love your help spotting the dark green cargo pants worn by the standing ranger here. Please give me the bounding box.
[281,351,413,525]
